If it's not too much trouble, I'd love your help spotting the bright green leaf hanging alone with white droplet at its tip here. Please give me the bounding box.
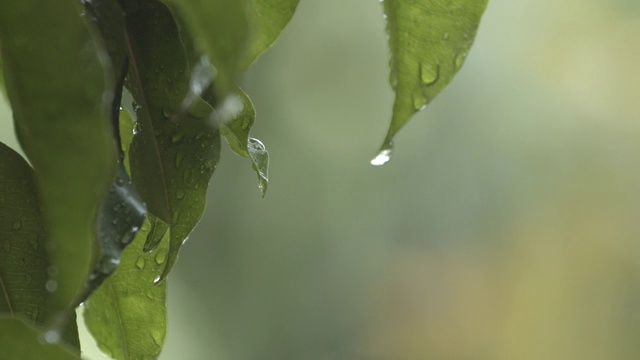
[378,0,487,165]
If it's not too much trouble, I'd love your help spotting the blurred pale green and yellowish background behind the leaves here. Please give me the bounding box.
[0,0,640,360]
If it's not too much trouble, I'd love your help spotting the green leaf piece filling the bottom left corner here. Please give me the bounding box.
[0,316,80,360]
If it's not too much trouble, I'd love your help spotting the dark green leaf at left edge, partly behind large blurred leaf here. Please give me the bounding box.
[0,143,51,324]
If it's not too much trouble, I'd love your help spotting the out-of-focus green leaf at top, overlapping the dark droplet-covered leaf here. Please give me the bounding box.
[164,0,252,97]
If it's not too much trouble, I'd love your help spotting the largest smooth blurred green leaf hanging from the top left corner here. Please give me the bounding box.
[0,0,117,316]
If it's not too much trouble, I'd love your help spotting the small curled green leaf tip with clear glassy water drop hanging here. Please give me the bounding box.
[218,89,269,197]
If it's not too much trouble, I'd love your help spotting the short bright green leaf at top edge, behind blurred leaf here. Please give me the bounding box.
[244,0,299,68]
